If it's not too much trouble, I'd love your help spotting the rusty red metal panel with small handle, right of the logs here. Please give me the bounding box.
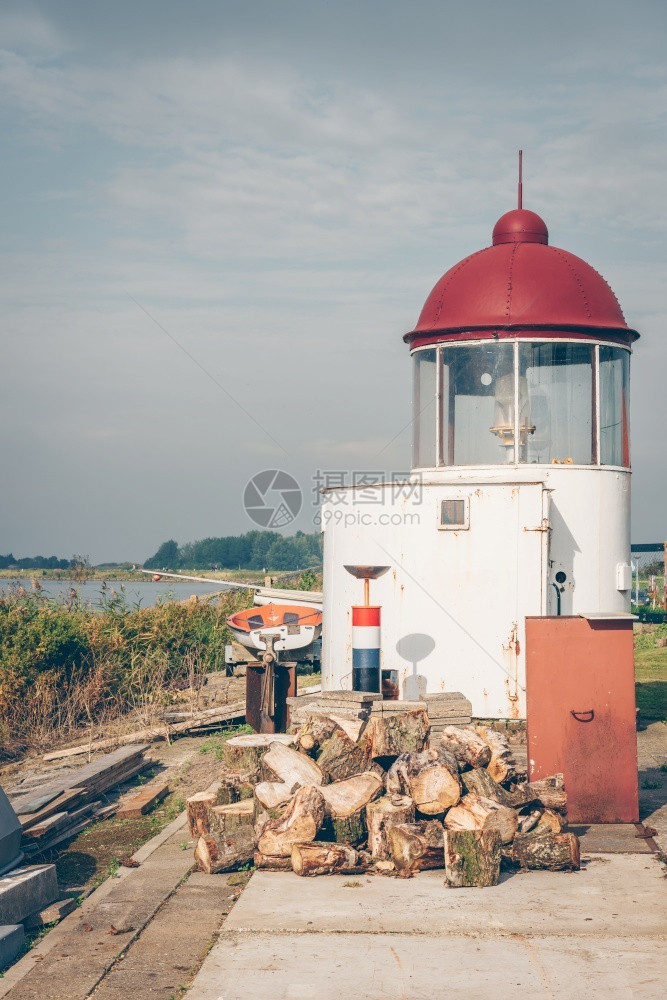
[526,616,639,823]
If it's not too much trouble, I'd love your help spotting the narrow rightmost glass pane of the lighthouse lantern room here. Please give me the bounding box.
[600,347,630,468]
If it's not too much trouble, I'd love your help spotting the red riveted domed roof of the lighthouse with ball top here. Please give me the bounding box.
[404,208,639,348]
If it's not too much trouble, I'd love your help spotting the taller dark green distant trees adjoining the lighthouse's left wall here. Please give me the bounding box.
[144,531,322,570]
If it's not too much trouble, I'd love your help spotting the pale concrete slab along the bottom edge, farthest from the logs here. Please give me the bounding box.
[187,933,667,1000]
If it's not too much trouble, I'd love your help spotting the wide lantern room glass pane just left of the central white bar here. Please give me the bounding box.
[442,343,514,465]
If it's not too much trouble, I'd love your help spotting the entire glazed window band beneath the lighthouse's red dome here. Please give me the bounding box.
[413,340,630,469]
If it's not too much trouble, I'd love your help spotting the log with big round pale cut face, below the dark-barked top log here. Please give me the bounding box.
[387,748,461,816]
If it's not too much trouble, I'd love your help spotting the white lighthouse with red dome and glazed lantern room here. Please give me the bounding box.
[322,195,638,719]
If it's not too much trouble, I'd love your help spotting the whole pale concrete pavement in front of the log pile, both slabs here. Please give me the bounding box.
[188,855,667,1000]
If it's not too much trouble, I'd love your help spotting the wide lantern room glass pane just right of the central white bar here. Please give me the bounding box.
[519,344,595,465]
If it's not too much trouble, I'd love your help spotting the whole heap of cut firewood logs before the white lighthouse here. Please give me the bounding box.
[187,710,579,886]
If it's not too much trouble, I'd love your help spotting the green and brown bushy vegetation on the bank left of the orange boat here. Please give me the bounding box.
[0,589,252,748]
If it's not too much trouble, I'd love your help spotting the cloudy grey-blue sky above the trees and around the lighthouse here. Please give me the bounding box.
[0,0,667,562]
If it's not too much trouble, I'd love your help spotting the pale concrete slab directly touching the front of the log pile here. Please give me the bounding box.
[225,854,667,936]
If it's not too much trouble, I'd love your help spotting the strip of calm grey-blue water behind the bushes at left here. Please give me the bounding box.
[0,577,239,608]
